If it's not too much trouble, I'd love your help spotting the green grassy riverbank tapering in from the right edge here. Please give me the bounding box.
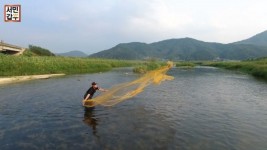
[200,58,267,80]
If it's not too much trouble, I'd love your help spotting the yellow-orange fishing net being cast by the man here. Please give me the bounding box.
[83,62,174,107]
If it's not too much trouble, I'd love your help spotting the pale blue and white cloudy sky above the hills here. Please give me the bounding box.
[0,0,267,54]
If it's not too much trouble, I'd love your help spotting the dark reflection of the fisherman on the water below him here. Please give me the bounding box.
[83,107,97,135]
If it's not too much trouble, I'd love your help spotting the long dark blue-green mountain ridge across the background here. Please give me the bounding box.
[89,38,267,60]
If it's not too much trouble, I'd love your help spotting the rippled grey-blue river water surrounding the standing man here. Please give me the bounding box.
[0,67,267,150]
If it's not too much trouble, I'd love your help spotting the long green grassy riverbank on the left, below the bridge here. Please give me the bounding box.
[0,54,142,76]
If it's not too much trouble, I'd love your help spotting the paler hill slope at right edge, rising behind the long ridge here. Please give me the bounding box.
[234,30,267,47]
